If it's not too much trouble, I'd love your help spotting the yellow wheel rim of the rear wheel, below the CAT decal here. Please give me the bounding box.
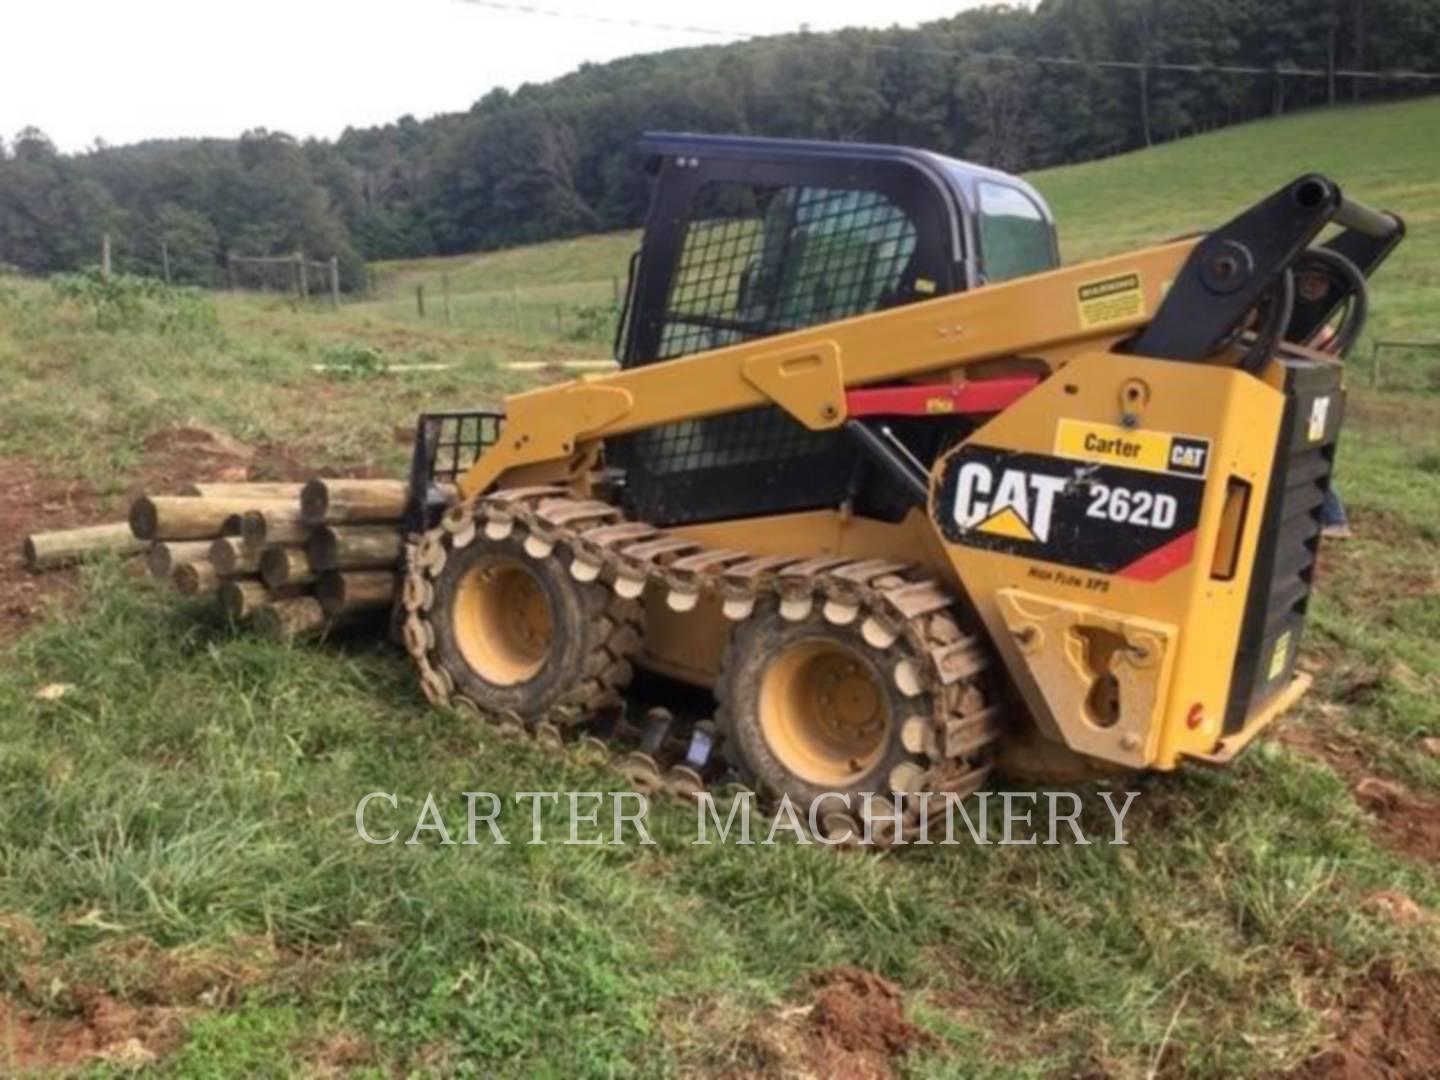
[760,641,891,788]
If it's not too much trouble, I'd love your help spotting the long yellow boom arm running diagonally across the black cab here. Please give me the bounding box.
[461,239,1197,497]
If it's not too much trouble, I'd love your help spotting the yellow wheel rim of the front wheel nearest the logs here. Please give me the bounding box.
[452,556,554,687]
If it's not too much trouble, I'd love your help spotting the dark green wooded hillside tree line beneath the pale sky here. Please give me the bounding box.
[0,0,1440,287]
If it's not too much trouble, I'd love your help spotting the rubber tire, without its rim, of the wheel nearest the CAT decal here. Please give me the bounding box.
[716,602,932,806]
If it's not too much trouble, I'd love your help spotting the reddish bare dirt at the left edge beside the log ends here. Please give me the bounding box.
[0,461,100,642]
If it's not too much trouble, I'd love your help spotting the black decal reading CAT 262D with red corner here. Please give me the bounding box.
[933,445,1205,582]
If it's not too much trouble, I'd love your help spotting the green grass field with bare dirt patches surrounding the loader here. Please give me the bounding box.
[0,99,1440,1077]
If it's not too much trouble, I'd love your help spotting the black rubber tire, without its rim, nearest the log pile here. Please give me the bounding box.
[429,536,628,721]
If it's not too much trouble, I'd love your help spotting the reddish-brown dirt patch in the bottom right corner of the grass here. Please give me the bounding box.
[1286,963,1440,1080]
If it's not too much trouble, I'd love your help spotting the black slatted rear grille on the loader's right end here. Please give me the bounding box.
[1225,359,1345,734]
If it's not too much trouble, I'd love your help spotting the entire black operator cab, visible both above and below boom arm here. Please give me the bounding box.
[605,134,1060,526]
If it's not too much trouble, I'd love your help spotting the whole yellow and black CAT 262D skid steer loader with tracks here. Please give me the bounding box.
[397,135,1404,841]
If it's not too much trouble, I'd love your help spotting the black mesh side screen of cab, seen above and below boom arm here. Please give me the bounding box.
[609,181,916,524]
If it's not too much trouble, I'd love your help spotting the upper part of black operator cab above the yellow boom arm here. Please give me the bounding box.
[616,134,1060,367]
